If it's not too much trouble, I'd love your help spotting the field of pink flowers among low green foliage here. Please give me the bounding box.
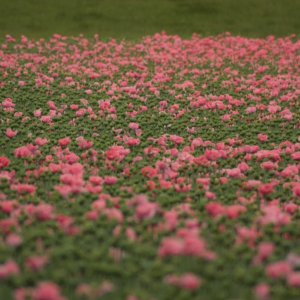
[0,33,300,300]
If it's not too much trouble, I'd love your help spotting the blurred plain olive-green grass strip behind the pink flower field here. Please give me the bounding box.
[0,0,300,40]
